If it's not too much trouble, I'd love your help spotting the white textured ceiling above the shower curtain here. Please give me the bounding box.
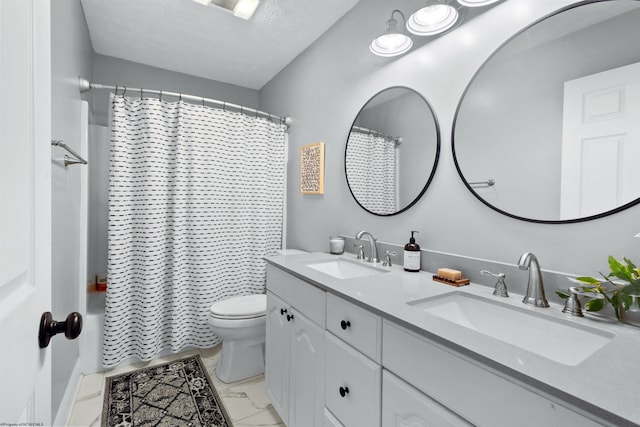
[81,0,359,89]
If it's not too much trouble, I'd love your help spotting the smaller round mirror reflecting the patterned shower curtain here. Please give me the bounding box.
[344,87,440,216]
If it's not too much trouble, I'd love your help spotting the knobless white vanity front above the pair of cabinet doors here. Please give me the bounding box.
[267,264,327,328]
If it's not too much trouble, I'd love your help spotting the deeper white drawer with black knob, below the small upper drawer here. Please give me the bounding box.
[325,332,382,427]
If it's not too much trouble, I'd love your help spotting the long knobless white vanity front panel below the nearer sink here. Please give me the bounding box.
[382,320,602,427]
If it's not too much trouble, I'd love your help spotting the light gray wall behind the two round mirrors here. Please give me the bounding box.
[260,0,640,280]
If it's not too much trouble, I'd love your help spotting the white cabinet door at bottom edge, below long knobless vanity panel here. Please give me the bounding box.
[382,370,472,427]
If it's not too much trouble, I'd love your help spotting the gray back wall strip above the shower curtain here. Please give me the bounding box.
[91,54,259,126]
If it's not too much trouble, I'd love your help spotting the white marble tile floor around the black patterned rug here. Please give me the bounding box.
[67,345,284,427]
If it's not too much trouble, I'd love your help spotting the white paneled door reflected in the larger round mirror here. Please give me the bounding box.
[560,63,640,219]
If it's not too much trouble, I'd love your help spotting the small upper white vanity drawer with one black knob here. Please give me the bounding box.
[327,293,382,363]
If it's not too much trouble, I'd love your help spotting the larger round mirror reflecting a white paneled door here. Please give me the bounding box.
[452,0,640,223]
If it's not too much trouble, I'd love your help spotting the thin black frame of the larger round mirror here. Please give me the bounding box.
[451,0,640,224]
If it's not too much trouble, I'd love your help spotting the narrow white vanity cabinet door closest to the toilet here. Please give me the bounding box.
[265,291,291,424]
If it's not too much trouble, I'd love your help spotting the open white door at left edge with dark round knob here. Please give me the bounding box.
[0,0,51,425]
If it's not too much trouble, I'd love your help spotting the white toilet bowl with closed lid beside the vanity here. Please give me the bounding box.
[209,294,267,383]
